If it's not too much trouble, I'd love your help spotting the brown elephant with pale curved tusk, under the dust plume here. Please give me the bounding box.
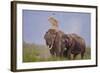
[44,29,64,57]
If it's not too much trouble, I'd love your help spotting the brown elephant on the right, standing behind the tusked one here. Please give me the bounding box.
[62,34,86,59]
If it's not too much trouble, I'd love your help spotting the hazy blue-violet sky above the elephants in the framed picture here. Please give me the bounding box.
[22,10,91,46]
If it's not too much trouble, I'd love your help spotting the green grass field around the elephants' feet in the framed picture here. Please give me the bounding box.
[23,43,91,62]
